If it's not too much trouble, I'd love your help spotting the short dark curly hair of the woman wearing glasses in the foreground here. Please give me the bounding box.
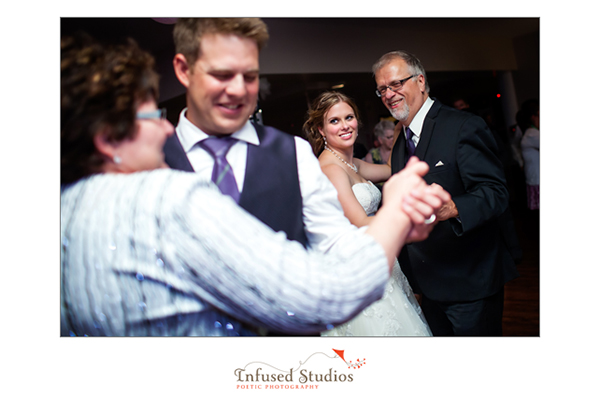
[60,33,158,184]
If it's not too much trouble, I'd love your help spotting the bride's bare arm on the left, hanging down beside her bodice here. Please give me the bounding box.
[321,164,372,227]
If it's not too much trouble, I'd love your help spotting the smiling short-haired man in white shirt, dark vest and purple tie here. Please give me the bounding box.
[164,18,360,251]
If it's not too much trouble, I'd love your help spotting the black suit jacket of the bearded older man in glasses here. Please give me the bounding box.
[391,101,518,302]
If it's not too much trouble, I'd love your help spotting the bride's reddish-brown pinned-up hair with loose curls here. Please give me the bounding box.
[302,91,360,157]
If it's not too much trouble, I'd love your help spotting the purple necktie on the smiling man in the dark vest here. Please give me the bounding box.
[198,136,240,203]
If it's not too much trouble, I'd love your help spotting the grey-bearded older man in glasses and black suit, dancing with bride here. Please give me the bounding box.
[373,51,518,336]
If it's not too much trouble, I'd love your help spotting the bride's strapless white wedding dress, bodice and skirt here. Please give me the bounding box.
[321,182,431,336]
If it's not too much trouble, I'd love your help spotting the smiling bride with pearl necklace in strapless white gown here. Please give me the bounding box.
[303,92,431,336]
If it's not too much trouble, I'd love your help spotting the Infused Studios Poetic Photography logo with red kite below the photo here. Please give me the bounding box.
[234,349,366,390]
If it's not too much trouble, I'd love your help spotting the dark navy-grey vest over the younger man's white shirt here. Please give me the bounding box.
[164,124,308,247]
